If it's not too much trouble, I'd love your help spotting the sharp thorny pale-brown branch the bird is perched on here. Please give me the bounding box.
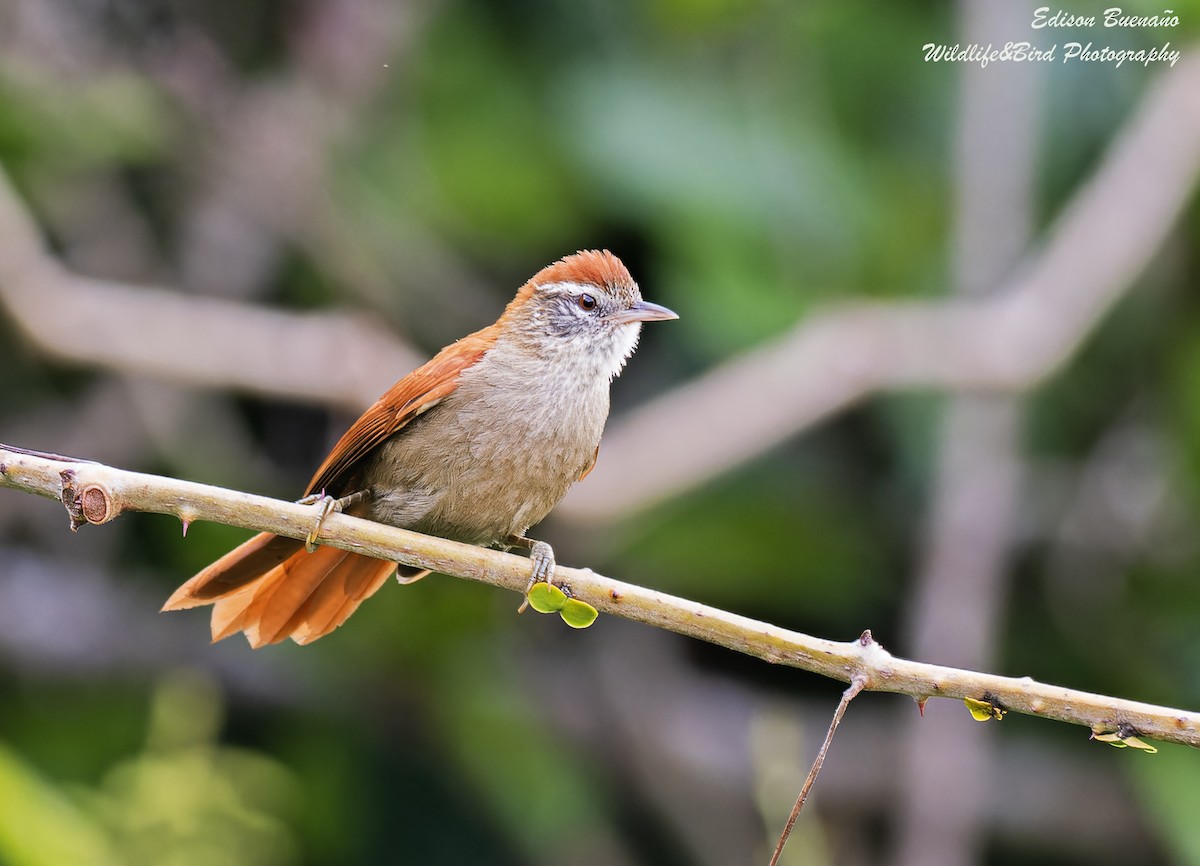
[0,446,1200,746]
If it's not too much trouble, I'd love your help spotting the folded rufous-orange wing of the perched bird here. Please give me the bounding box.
[306,329,494,495]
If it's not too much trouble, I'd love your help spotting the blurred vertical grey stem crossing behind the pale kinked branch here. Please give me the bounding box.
[890,0,1045,866]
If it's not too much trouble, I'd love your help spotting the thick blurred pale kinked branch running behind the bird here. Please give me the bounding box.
[0,50,1200,522]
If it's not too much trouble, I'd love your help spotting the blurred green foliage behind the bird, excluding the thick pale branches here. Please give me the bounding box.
[0,0,1200,866]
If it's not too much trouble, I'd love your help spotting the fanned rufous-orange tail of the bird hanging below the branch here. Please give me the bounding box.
[162,533,396,649]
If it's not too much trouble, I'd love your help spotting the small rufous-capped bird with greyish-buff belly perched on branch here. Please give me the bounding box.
[162,249,678,649]
